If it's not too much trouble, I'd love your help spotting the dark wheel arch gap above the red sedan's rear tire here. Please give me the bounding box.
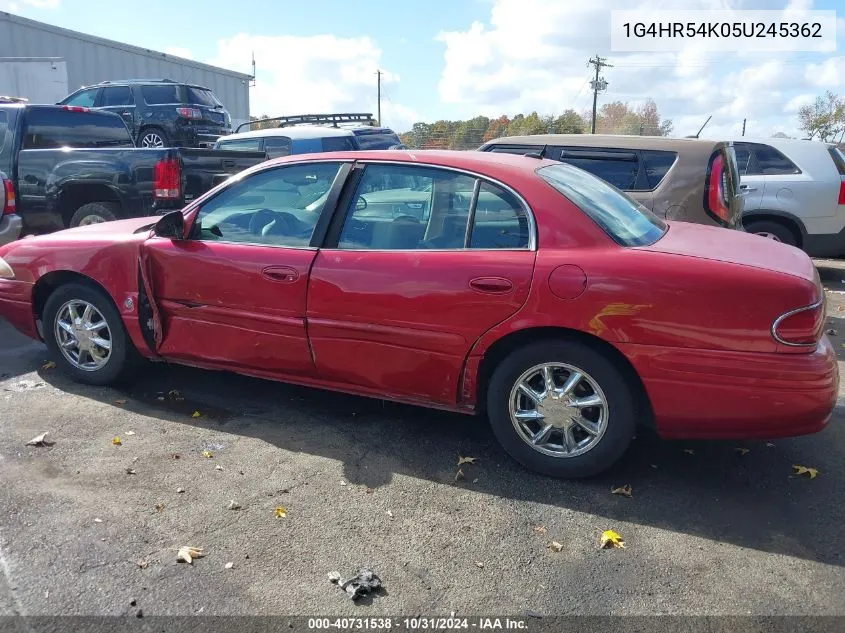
[475,326,655,428]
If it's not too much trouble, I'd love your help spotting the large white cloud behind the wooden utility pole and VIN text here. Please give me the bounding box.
[437,0,845,135]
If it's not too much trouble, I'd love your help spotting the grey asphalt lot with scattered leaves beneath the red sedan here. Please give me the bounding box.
[0,261,845,616]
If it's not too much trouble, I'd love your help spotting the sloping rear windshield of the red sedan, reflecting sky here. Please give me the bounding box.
[537,163,666,246]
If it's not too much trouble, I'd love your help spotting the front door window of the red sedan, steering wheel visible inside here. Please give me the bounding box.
[194,162,342,248]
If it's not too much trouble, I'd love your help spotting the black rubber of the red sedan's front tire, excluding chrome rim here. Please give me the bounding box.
[42,284,131,385]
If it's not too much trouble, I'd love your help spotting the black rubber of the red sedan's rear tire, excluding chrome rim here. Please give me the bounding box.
[487,341,636,478]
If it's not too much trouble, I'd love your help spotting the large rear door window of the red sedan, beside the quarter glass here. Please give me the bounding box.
[338,165,475,250]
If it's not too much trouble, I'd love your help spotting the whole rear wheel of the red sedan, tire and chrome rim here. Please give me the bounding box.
[487,341,636,478]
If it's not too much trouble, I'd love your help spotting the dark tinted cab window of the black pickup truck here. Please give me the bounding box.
[23,108,134,149]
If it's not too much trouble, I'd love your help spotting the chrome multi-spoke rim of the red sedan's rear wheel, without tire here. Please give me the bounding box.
[508,363,608,457]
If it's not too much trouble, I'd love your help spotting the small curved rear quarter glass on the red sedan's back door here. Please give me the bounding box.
[469,182,530,248]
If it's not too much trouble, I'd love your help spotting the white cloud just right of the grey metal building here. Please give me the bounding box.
[207,33,418,129]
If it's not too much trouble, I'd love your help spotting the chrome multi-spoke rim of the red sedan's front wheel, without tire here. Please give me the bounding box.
[54,299,112,371]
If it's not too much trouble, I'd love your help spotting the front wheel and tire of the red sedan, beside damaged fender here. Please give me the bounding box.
[42,283,140,385]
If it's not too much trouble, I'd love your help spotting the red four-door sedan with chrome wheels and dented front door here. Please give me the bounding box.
[0,151,839,477]
